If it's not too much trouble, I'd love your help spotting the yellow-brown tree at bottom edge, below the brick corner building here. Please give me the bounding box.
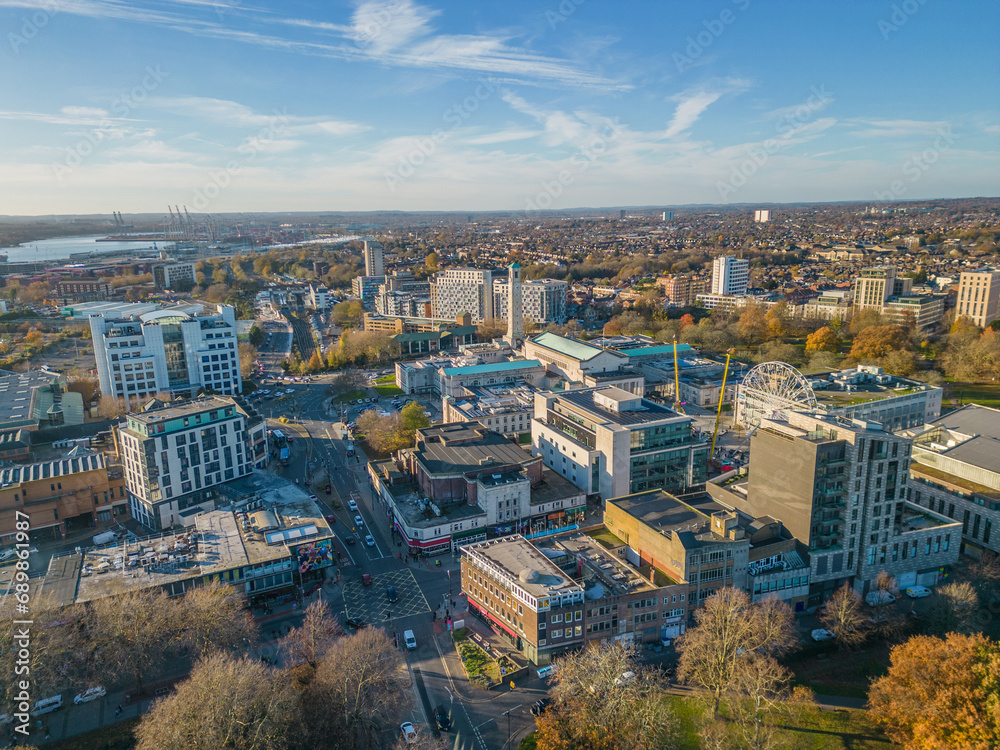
[536,643,673,750]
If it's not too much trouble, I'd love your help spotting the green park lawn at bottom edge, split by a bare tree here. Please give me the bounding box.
[668,696,897,750]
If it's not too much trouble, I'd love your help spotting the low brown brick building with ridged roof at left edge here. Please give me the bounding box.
[0,449,128,545]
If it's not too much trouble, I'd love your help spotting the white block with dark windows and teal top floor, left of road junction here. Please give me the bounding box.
[118,396,267,531]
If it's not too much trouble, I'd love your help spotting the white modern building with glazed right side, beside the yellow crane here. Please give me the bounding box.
[531,387,709,499]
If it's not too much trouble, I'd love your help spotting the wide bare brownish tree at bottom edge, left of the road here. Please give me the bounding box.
[136,654,302,750]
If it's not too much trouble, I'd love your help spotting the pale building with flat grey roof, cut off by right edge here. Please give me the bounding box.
[906,404,1000,558]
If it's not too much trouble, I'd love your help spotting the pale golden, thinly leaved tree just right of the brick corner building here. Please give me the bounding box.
[677,587,797,716]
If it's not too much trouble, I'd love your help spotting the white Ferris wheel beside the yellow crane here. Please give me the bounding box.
[736,362,816,430]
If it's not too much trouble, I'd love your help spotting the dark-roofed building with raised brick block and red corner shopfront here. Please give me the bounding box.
[368,422,586,552]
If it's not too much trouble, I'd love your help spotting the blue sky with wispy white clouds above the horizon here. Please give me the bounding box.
[0,0,1000,214]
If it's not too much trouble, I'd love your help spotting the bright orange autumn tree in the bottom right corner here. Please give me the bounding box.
[868,633,1000,750]
